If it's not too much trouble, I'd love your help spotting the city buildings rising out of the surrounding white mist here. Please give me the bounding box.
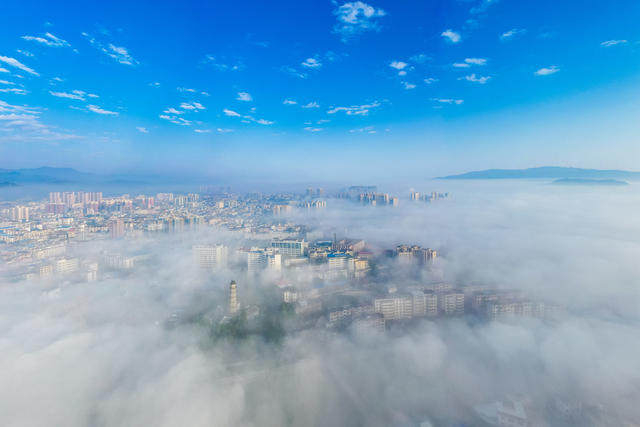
[0,186,555,329]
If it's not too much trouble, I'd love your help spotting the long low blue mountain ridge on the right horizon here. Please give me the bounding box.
[435,166,640,180]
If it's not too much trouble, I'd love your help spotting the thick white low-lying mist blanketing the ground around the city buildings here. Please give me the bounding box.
[0,182,640,427]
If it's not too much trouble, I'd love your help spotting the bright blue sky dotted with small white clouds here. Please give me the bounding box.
[0,0,640,178]
